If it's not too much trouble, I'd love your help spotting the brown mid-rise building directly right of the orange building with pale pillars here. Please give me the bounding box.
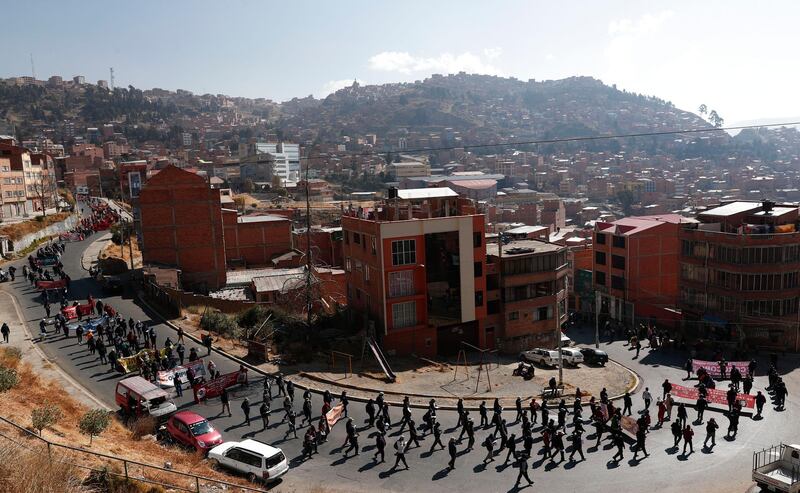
[486,239,569,353]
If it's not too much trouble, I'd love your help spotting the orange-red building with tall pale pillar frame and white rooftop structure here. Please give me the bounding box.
[342,188,484,356]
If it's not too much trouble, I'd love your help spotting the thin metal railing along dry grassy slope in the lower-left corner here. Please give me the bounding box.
[0,417,266,493]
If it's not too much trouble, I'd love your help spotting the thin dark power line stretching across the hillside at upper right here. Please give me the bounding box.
[306,121,800,159]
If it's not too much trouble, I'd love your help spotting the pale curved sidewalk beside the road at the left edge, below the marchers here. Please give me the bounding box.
[0,286,110,410]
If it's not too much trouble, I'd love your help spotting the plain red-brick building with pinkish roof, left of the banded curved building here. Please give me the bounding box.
[592,214,696,327]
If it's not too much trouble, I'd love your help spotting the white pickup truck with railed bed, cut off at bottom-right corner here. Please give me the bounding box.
[753,443,800,493]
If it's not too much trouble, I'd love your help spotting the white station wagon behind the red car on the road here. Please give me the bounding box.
[208,439,289,482]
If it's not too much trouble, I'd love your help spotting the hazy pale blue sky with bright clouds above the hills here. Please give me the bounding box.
[0,0,800,124]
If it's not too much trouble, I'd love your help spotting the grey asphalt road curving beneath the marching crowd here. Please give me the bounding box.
[2,225,800,492]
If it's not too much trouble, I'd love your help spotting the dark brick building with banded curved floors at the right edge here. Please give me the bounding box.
[679,202,800,351]
